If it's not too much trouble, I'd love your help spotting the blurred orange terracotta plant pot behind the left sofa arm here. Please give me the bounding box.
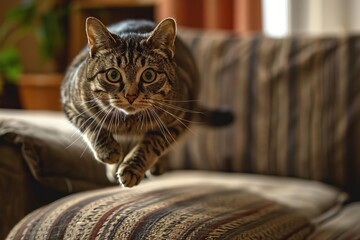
[19,73,64,111]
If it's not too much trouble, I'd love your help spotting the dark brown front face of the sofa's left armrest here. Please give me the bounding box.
[0,143,66,239]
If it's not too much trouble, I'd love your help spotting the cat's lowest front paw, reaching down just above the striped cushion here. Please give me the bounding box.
[117,157,145,187]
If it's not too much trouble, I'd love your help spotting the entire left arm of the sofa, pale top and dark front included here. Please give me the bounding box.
[0,113,112,239]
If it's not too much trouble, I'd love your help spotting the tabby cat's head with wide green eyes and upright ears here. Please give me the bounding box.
[86,17,176,114]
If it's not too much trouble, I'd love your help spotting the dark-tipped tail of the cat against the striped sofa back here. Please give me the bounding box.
[193,107,234,127]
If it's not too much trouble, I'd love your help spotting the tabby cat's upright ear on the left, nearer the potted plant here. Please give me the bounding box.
[86,17,116,56]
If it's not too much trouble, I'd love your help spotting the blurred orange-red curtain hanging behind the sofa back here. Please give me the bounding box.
[155,0,262,33]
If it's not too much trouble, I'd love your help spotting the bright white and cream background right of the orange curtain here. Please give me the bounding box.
[262,0,360,37]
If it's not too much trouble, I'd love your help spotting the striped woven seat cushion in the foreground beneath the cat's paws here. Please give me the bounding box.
[7,171,344,240]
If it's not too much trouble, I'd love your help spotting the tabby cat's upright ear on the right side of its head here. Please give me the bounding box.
[147,18,176,58]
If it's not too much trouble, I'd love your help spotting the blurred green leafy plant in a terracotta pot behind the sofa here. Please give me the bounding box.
[0,0,68,110]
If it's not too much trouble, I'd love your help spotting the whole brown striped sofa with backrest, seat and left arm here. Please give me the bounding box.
[0,29,360,240]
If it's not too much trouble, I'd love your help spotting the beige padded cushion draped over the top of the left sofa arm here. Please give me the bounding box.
[0,111,111,193]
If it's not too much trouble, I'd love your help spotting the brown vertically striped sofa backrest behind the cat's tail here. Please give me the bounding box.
[171,29,360,199]
